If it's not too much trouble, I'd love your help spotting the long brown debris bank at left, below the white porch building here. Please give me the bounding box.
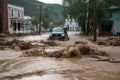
[0,39,58,50]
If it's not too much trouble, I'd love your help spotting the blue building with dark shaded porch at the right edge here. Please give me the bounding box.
[99,6,120,36]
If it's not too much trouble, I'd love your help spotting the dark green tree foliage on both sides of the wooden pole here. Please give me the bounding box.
[63,0,120,35]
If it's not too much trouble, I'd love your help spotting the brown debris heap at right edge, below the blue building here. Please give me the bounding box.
[97,38,120,46]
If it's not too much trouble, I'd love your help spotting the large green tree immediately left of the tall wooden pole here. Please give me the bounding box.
[63,0,89,34]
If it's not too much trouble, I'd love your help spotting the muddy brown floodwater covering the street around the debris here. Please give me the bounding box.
[0,32,120,80]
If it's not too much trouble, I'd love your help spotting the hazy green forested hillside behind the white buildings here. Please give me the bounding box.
[8,0,63,20]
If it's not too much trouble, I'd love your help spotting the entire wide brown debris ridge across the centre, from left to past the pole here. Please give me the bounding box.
[22,40,109,58]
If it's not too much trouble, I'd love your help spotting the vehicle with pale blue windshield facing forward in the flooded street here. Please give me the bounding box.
[49,27,68,40]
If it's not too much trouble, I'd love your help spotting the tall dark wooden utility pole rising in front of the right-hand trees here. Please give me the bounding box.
[93,0,97,42]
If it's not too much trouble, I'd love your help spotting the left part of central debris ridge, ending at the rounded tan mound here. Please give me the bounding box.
[22,47,81,58]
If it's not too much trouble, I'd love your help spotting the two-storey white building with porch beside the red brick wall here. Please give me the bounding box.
[8,4,31,34]
